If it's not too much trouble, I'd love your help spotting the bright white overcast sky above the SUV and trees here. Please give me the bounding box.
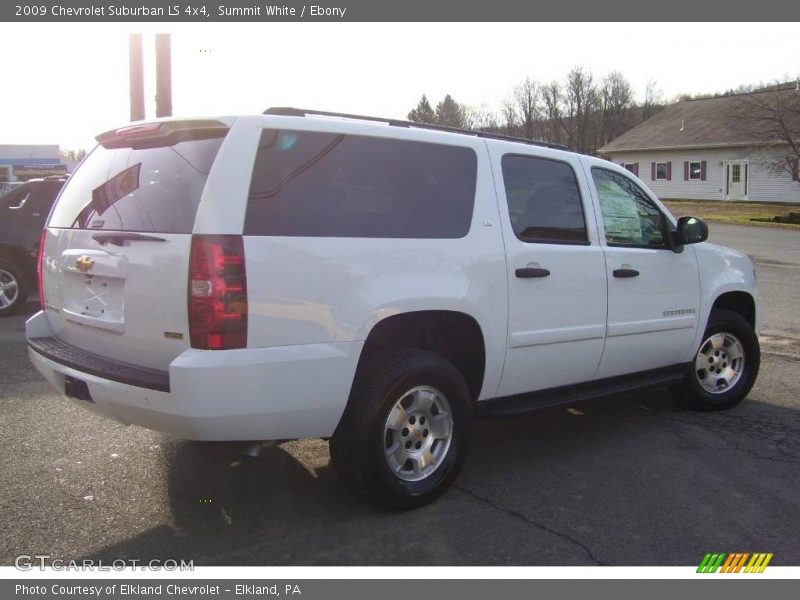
[0,23,800,149]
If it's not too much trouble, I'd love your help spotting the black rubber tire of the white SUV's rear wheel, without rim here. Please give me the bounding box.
[330,349,473,510]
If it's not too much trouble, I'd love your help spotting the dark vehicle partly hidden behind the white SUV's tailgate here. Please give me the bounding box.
[0,177,66,317]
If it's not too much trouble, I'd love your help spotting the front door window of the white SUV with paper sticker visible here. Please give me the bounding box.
[592,168,665,248]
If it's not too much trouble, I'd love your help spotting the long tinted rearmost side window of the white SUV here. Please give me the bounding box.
[244,129,477,238]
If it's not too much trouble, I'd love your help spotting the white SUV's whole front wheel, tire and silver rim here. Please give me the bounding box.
[675,309,761,410]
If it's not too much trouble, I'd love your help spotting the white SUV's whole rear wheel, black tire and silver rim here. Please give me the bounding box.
[330,349,472,509]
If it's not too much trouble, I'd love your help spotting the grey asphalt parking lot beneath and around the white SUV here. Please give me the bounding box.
[0,225,800,565]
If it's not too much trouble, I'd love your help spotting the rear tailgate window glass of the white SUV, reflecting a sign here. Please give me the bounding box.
[49,137,222,233]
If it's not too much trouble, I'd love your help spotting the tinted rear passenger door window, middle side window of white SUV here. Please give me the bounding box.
[503,154,589,244]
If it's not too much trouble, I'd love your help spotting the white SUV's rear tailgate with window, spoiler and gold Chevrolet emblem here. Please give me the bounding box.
[43,121,228,370]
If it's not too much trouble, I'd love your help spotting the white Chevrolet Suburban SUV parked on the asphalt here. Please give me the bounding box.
[27,109,759,508]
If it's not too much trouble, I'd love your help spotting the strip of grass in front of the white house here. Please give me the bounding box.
[663,199,800,229]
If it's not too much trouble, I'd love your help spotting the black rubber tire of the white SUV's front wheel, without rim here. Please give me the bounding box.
[673,309,761,410]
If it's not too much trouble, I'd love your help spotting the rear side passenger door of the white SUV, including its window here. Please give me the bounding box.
[492,145,606,396]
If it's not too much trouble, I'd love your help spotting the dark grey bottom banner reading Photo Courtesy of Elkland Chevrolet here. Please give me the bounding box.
[0,573,797,600]
